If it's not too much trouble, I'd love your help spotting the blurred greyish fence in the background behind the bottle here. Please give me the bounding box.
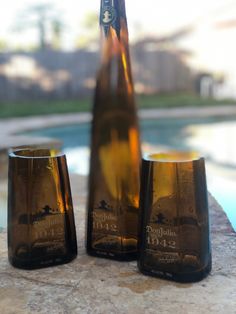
[0,45,194,102]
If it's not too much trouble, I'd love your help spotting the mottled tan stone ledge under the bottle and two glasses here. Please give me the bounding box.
[0,176,236,314]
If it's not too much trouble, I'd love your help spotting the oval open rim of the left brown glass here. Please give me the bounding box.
[8,148,66,159]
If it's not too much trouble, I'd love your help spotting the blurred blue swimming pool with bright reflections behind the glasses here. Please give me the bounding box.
[27,117,236,229]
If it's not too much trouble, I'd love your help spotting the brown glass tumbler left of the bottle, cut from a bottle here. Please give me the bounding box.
[8,149,77,269]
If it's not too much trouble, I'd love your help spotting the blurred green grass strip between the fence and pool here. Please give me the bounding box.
[0,94,236,118]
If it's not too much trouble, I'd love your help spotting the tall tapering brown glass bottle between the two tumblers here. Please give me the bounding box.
[87,0,140,260]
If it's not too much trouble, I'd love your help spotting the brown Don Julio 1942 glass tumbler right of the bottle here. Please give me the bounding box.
[138,152,211,282]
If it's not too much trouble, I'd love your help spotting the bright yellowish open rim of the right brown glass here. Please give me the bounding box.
[143,150,204,163]
